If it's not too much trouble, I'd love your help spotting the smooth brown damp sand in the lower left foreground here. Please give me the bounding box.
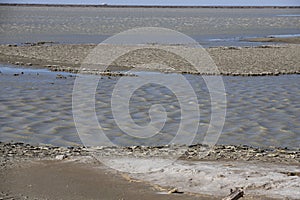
[0,160,209,200]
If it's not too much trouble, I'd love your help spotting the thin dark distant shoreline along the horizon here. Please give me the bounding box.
[0,3,300,9]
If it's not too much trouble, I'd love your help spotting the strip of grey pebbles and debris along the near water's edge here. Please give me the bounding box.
[0,142,300,166]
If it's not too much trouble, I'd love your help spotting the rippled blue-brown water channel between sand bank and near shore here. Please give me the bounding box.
[0,65,300,147]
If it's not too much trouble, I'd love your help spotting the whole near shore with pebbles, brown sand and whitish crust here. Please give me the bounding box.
[0,142,300,200]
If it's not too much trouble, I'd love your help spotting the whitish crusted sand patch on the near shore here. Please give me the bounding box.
[101,158,300,199]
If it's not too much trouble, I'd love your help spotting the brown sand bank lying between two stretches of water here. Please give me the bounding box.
[0,44,300,76]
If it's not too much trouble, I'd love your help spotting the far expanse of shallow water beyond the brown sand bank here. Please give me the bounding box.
[0,6,300,46]
